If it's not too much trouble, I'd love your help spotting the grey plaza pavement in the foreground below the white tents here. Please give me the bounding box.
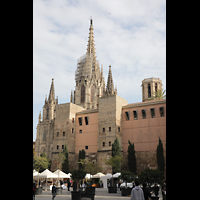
[35,188,162,200]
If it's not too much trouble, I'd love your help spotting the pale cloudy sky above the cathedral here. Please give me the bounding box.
[33,0,166,141]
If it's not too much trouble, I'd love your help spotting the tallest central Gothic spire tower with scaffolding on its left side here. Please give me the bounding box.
[73,19,105,109]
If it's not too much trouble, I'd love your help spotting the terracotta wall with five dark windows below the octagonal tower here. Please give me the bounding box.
[122,101,166,152]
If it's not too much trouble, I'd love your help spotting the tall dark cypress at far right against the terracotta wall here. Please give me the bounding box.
[156,137,165,174]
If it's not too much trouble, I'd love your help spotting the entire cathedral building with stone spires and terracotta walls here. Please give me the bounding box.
[35,19,166,173]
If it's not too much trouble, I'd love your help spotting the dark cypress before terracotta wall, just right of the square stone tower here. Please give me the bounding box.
[128,141,137,174]
